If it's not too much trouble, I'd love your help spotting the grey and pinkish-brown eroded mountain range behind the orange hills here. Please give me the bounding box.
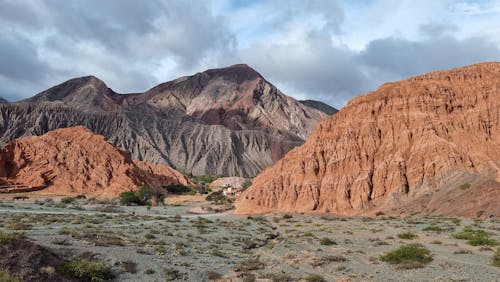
[0,64,327,176]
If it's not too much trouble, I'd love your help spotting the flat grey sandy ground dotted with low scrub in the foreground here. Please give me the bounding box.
[0,197,500,281]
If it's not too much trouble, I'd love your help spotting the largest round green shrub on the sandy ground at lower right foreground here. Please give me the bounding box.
[380,244,433,269]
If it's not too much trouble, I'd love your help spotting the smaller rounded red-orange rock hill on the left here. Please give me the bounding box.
[0,126,190,196]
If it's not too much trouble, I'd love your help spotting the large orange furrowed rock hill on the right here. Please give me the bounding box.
[237,63,500,215]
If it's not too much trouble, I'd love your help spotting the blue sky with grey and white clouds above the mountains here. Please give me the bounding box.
[0,0,500,107]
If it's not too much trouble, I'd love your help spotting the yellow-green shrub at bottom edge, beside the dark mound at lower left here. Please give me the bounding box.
[59,259,112,281]
